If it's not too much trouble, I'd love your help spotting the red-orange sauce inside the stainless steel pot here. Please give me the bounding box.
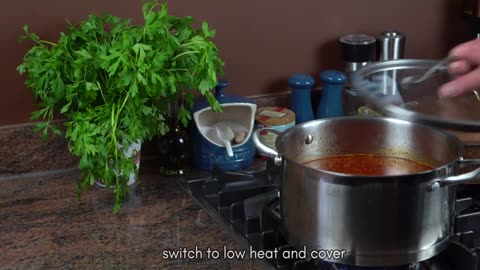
[304,154,433,176]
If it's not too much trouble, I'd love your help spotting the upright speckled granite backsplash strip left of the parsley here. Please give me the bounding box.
[0,124,77,176]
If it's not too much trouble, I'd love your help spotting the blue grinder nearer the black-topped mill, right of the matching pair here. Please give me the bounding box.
[316,70,347,119]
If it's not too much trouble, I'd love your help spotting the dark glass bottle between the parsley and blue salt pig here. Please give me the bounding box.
[156,103,191,175]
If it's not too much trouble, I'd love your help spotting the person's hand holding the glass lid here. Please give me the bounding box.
[438,39,480,97]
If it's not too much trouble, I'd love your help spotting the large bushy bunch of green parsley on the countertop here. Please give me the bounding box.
[17,0,223,213]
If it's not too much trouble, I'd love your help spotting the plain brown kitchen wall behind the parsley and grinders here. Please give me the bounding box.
[0,0,469,126]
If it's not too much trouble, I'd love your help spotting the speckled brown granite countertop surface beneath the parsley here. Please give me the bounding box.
[0,170,260,269]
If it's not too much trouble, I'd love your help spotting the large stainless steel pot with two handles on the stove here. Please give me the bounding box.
[253,117,480,266]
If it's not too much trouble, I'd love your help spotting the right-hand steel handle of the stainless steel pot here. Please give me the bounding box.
[427,159,480,191]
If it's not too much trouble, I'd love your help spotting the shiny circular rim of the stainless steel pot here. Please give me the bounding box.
[275,116,464,181]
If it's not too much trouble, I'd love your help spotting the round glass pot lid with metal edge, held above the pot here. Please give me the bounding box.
[352,59,480,131]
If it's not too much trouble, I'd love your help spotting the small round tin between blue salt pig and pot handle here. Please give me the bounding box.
[255,107,295,157]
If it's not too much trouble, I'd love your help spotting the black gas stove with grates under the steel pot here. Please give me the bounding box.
[179,161,480,270]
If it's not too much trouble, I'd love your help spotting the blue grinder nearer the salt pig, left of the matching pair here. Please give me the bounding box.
[288,74,315,124]
